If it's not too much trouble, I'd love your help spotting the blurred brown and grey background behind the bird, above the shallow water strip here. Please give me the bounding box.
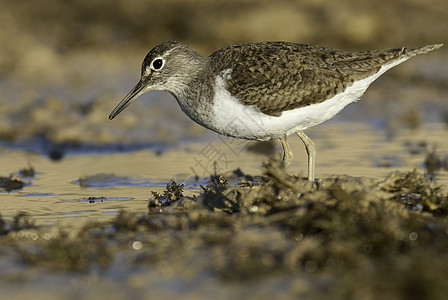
[0,0,448,153]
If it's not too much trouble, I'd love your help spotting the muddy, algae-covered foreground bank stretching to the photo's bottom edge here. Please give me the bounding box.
[0,157,448,299]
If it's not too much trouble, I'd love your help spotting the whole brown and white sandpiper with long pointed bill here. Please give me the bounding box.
[109,41,442,181]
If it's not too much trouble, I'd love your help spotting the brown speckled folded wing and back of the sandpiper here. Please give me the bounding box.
[210,42,406,116]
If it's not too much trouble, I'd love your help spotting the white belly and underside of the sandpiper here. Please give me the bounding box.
[207,58,408,141]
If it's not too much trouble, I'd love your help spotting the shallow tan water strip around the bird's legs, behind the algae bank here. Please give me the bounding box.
[0,122,448,226]
